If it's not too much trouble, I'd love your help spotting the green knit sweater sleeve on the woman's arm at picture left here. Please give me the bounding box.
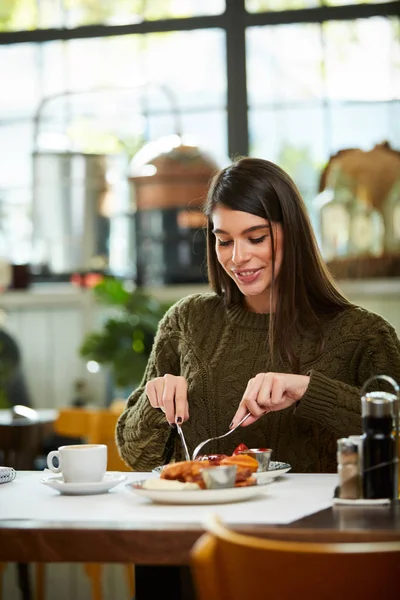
[116,307,180,471]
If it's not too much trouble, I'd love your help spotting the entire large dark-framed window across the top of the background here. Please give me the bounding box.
[0,0,400,272]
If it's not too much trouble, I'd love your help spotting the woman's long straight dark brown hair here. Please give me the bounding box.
[204,158,352,372]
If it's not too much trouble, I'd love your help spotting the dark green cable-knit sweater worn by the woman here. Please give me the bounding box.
[116,293,400,473]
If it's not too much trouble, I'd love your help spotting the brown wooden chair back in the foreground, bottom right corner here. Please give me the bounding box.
[191,505,400,600]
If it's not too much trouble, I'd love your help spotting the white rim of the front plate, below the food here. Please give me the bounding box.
[126,480,268,504]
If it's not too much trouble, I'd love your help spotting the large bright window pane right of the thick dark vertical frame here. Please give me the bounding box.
[247,17,400,219]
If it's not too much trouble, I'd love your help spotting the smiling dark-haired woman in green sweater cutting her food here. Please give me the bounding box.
[117,158,400,472]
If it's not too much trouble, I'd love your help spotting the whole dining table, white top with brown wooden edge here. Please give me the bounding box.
[0,472,400,600]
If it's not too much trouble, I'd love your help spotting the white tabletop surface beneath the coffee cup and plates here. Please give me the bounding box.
[0,470,337,529]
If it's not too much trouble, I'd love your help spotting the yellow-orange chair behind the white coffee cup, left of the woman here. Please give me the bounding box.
[36,407,135,600]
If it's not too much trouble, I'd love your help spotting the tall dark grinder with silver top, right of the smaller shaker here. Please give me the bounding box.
[361,375,399,500]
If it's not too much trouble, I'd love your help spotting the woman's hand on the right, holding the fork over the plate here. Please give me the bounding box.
[230,373,310,428]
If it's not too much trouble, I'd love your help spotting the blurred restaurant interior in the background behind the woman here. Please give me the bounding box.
[0,0,400,600]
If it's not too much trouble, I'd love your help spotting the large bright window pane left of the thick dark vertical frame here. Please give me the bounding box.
[0,29,227,218]
